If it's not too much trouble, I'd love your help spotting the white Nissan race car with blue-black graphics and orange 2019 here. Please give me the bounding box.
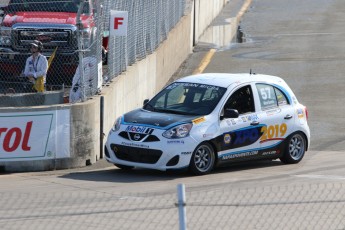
[105,73,310,175]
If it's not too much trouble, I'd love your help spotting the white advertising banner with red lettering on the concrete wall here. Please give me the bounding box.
[0,110,70,161]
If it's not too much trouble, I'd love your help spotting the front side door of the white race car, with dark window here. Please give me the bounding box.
[218,84,260,161]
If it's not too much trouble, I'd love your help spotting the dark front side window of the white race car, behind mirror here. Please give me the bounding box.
[225,85,255,114]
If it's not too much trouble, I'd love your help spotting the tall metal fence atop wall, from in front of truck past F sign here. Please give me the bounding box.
[0,0,185,107]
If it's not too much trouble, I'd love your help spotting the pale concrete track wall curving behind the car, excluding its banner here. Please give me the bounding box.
[0,0,228,171]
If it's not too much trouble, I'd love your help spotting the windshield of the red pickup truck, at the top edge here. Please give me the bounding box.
[8,0,89,13]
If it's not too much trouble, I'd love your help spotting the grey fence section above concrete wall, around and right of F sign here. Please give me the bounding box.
[104,0,186,80]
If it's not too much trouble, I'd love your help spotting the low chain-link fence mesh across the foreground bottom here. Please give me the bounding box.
[0,182,345,230]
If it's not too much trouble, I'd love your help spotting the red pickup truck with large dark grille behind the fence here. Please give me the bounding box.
[0,0,108,85]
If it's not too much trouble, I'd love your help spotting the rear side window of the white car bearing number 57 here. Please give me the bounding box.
[256,84,289,109]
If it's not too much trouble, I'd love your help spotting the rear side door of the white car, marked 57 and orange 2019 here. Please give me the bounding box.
[254,83,295,156]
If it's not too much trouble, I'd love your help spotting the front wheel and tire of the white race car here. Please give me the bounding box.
[189,142,216,175]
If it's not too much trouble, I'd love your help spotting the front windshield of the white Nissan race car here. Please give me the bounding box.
[144,82,226,115]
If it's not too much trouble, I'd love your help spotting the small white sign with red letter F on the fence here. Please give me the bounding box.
[109,10,128,36]
